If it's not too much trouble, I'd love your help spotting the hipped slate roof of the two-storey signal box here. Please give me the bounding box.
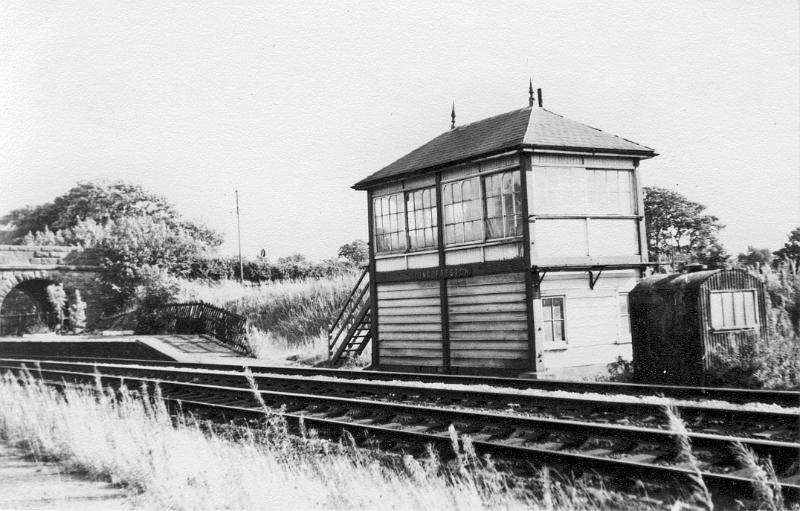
[353,106,655,190]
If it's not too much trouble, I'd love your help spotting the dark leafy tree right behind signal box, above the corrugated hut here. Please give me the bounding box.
[644,187,729,268]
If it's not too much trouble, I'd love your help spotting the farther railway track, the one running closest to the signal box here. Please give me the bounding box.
[5,360,800,442]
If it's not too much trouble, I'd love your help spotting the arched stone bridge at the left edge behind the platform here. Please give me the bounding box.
[0,245,103,334]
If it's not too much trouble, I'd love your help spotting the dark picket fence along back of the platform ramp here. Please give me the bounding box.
[142,302,252,355]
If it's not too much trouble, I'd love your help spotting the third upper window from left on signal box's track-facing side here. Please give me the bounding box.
[442,178,483,245]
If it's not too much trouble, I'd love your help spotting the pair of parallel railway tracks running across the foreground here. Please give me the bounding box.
[0,358,800,500]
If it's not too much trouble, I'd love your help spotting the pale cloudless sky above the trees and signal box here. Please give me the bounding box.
[0,0,800,259]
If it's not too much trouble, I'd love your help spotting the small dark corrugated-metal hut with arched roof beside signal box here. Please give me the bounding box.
[630,270,768,384]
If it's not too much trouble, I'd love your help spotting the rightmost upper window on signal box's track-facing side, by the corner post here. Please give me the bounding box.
[483,172,522,239]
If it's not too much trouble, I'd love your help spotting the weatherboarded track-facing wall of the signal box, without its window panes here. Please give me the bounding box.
[369,153,536,375]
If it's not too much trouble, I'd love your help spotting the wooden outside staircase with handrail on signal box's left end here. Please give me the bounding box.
[328,269,372,367]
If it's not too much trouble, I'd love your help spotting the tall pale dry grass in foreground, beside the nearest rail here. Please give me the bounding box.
[0,374,686,511]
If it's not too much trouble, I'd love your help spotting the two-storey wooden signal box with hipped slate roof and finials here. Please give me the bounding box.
[353,89,655,376]
